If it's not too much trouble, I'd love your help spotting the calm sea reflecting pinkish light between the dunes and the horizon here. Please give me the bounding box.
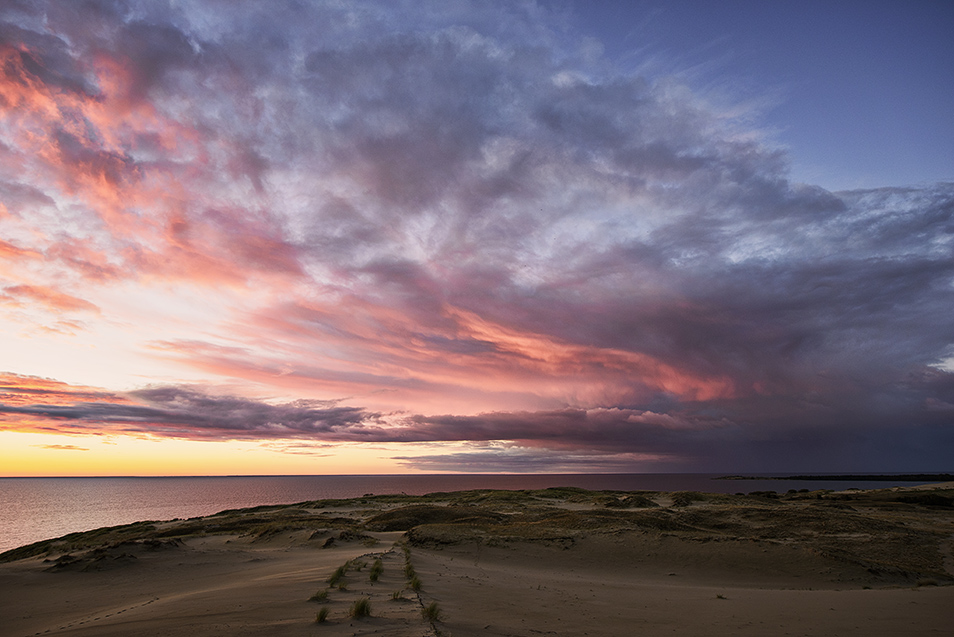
[0,473,936,552]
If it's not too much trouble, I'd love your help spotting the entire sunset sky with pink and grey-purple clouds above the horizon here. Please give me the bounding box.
[0,0,954,476]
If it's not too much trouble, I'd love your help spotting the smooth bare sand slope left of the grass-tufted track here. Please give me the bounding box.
[0,537,420,636]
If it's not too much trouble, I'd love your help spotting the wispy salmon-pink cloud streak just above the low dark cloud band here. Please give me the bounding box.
[154,296,736,411]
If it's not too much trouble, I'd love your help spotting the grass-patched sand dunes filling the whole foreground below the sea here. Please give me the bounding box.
[0,484,954,637]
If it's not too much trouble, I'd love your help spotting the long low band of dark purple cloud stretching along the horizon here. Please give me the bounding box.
[0,369,954,472]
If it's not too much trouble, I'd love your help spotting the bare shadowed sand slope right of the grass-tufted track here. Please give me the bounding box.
[415,542,954,637]
